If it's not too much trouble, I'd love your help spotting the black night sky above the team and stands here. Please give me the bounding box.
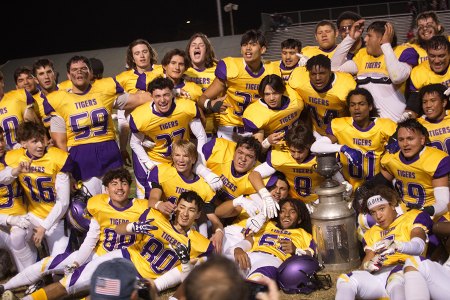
[0,0,406,65]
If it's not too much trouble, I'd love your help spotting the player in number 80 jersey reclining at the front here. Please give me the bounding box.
[19,191,213,300]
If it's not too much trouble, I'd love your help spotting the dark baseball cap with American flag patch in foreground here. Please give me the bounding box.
[90,257,138,300]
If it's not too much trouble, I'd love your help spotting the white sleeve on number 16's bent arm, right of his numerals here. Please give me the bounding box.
[41,173,70,230]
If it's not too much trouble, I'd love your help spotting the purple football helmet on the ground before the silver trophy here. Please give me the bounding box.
[277,255,332,294]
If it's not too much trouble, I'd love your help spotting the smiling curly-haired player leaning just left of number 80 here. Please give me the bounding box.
[0,168,148,292]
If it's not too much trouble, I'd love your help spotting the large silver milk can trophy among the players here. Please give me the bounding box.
[311,153,360,272]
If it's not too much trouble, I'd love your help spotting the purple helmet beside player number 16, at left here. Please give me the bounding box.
[66,186,92,233]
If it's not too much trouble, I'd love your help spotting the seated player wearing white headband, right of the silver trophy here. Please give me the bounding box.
[335,186,433,300]
